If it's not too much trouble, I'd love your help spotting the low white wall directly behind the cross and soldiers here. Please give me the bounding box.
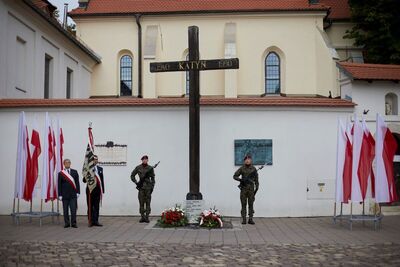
[0,107,352,219]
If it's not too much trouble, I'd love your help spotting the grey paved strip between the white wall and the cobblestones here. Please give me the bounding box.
[0,216,400,245]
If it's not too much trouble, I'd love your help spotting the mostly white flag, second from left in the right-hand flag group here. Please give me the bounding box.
[351,116,364,202]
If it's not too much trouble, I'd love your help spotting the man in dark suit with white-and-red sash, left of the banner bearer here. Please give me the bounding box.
[58,159,81,228]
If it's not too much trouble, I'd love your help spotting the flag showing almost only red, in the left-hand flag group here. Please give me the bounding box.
[24,121,41,201]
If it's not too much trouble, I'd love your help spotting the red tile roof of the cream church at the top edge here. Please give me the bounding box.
[69,0,328,17]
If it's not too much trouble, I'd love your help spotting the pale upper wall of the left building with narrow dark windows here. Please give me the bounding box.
[0,0,95,98]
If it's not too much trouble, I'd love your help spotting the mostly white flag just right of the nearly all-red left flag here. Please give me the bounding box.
[42,112,57,202]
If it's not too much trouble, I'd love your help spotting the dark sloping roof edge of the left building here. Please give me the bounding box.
[23,0,101,63]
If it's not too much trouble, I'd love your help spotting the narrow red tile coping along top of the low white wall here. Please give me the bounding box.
[0,96,355,108]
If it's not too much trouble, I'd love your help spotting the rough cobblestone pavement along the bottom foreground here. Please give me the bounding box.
[0,241,400,266]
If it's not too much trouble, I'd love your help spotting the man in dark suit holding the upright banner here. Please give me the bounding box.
[83,155,104,227]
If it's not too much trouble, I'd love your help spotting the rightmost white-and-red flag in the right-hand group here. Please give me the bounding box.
[375,114,398,203]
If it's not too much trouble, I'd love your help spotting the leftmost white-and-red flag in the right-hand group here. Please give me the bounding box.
[336,120,352,203]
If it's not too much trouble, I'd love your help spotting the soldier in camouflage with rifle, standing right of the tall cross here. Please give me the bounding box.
[233,155,258,224]
